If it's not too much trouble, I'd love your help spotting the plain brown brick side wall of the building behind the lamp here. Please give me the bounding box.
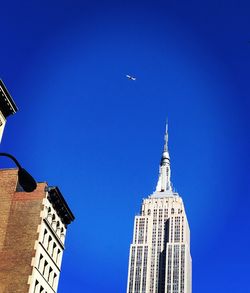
[0,169,46,293]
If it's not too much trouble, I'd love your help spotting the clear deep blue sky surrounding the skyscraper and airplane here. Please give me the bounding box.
[0,0,250,293]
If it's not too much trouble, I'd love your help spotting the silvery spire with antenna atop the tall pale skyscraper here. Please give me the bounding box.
[156,123,172,192]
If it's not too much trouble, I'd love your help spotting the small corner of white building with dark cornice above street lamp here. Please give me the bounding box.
[0,79,17,142]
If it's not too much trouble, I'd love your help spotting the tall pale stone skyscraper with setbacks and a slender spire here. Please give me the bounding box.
[127,126,192,293]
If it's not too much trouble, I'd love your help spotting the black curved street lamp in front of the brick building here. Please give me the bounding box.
[0,153,37,192]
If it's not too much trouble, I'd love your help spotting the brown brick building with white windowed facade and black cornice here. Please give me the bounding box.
[0,169,74,293]
